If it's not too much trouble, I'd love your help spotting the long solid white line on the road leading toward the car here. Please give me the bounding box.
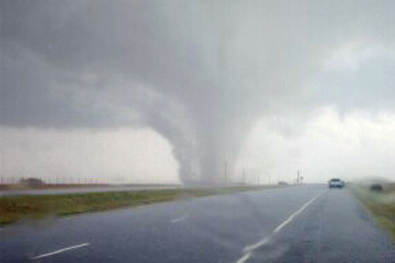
[236,191,325,263]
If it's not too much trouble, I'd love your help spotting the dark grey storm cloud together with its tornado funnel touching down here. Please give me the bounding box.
[0,0,395,185]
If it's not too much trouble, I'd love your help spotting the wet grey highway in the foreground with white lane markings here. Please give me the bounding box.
[0,185,395,263]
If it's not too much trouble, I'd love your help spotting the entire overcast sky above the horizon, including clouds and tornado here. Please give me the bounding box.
[0,0,395,186]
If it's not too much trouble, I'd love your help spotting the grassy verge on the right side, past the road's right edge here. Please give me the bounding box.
[351,184,395,241]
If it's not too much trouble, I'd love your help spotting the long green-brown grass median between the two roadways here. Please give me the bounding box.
[0,185,278,226]
